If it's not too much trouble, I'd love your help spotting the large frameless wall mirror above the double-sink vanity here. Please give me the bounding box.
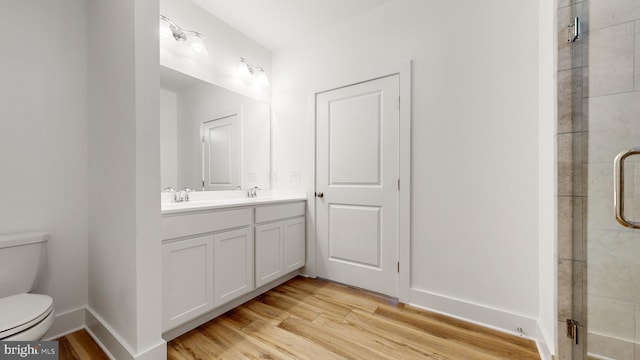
[160,66,271,190]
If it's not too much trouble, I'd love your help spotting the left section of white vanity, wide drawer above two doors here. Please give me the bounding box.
[161,208,253,331]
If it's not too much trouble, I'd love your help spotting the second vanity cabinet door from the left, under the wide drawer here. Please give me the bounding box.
[213,227,254,307]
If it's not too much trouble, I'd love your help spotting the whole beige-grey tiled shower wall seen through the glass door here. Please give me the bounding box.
[558,0,640,360]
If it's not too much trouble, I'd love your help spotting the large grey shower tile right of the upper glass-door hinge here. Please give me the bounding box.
[589,23,635,96]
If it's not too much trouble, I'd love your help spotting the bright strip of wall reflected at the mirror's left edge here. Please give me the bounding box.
[160,89,178,189]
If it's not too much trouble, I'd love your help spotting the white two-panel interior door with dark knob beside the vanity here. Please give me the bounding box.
[316,75,399,297]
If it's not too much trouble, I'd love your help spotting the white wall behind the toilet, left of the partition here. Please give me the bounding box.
[0,0,88,330]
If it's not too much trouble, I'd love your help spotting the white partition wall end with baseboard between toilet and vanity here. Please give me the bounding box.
[87,0,166,359]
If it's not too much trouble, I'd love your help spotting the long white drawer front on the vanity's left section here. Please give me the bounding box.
[161,208,253,240]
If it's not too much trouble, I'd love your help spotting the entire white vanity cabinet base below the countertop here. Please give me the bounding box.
[161,201,306,336]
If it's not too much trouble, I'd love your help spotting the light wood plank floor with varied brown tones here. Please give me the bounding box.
[53,277,540,360]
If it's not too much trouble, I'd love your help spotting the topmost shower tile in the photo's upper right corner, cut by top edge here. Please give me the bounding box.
[589,0,640,30]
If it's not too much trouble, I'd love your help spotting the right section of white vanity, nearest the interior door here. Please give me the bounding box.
[255,202,305,287]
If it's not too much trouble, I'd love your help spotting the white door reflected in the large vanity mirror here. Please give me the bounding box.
[202,114,240,190]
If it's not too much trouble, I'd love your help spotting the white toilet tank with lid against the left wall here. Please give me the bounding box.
[0,232,49,298]
